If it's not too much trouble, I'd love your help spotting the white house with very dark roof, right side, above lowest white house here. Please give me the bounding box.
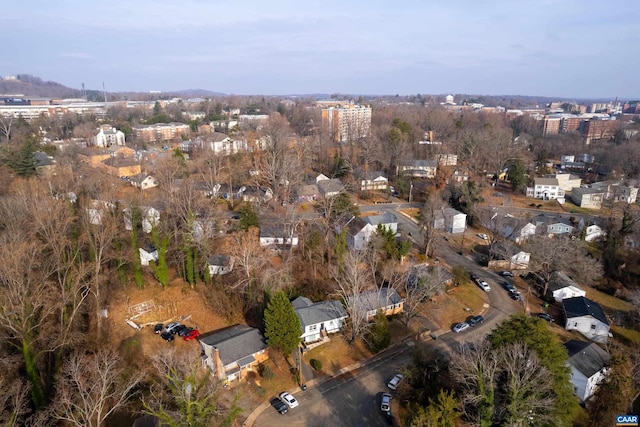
[562,297,609,343]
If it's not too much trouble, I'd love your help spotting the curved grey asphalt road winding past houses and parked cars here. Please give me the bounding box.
[254,204,523,427]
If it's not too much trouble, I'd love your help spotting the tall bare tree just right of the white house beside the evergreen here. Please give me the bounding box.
[331,250,376,344]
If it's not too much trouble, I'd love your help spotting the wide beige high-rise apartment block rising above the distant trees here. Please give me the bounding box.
[322,104,371,142]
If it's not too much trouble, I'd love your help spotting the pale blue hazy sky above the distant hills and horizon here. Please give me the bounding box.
[0,0,640,98]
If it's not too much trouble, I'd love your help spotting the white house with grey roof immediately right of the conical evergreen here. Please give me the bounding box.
[291,297,348,343]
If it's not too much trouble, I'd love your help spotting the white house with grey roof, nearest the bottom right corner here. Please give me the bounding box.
[564,340,611,403]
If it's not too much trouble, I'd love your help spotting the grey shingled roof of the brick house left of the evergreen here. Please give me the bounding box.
[198,325,267,365]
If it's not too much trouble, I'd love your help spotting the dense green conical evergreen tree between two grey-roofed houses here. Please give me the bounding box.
[264,291,302,355]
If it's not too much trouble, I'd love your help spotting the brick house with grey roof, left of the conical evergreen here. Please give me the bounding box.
[198,325,269,382]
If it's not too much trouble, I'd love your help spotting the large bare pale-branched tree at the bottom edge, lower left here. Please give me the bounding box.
[50,350,145,427]
